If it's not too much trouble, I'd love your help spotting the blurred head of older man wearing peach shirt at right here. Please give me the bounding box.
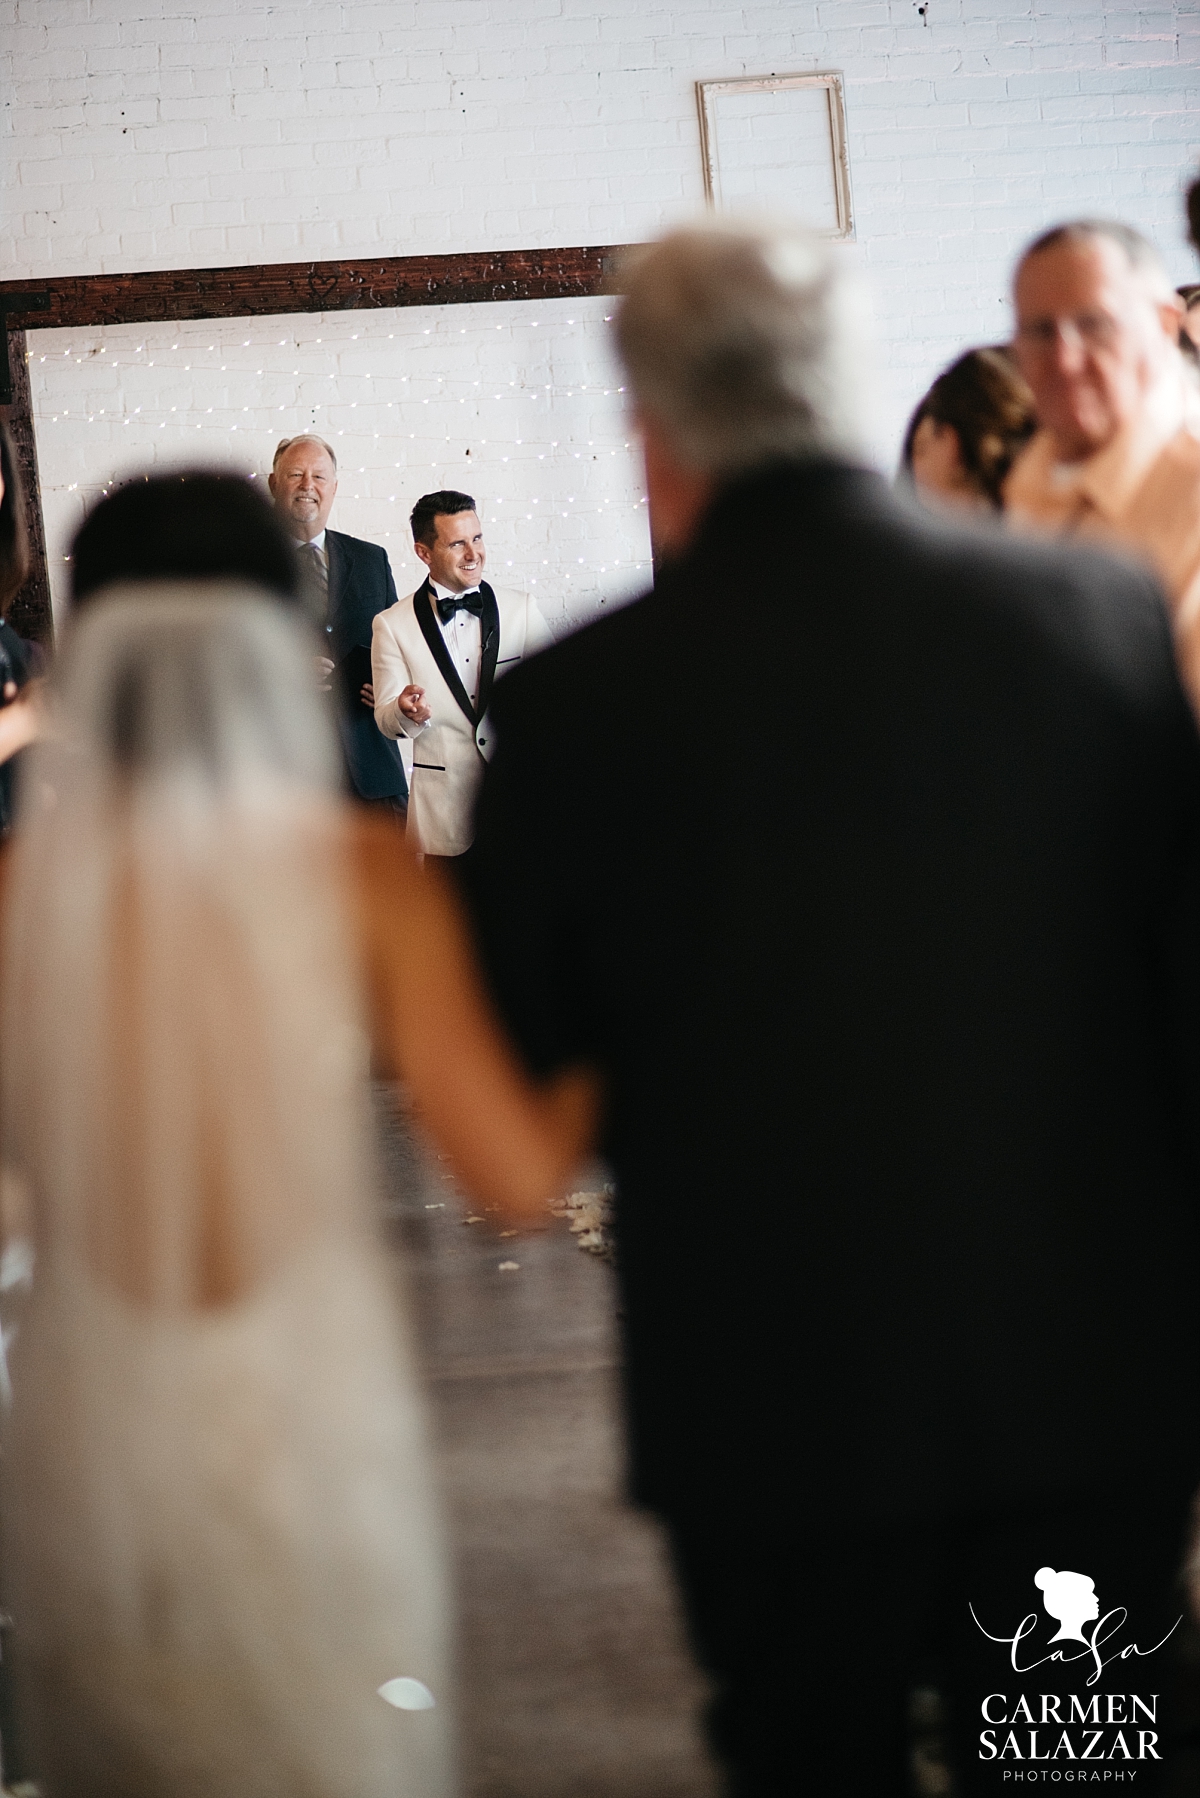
[1013,219,1180,462]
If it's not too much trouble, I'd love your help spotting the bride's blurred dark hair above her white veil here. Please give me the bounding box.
[70,469,299,606]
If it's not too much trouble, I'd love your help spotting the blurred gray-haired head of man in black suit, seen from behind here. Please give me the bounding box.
[617,223,869,476]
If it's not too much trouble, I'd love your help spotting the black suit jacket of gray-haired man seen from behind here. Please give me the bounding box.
[464,464,1200,1528]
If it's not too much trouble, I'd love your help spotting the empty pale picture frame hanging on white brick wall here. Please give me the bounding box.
[696,74,855,237]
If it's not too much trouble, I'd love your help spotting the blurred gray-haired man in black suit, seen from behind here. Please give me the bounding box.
[464,227,1200,1798]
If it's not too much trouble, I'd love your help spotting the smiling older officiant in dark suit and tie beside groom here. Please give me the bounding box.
[268,435,408,813]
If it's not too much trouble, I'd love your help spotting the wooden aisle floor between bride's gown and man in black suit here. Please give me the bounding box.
[383,1109,718,1798]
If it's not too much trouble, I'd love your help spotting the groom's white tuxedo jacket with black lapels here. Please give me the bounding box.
[371,581,552,856]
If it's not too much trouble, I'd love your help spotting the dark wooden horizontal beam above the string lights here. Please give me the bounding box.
[0,245,628,331]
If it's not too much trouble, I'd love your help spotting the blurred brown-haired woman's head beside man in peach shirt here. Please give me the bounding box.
[901,345,1036,512]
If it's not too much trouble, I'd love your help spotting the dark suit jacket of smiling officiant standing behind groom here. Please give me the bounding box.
[326,530,408,798]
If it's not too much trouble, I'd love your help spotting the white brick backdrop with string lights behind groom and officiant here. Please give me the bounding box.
[29,298,649,635]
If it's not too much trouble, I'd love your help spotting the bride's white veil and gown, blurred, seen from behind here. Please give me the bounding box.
[2,583,453,1798]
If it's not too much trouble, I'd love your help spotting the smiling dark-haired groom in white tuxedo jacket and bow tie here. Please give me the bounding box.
[371,491,552,856]
